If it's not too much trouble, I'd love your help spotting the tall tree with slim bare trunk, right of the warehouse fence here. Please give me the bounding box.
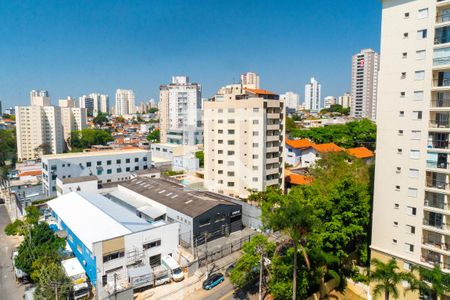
[262,187,320,299]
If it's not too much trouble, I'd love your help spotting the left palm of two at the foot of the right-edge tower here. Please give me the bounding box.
[369,258,414,300]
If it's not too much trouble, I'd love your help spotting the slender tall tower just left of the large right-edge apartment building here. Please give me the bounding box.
[350,49,380,121]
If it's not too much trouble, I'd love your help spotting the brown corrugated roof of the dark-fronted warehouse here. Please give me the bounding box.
[119,177,236,218]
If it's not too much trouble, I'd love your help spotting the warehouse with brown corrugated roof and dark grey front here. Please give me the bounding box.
[107,177,242,248]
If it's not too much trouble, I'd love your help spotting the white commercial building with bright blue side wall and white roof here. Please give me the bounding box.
[47,192,179,299]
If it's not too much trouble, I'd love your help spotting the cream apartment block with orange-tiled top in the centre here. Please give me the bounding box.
[203,84,285,198]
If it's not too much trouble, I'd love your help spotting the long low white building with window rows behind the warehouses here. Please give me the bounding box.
[42,148,151,196]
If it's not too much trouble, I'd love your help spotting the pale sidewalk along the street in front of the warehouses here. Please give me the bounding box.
[135,251,241,300]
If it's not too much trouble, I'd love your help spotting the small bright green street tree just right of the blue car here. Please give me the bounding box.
[230,234,275,288]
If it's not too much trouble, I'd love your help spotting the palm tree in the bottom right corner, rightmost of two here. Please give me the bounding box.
[410,265,450,300]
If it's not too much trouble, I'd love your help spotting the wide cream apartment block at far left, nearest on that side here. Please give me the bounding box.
[15,102,64,161]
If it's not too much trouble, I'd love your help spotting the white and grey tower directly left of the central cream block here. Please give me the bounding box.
[158,76,203,145]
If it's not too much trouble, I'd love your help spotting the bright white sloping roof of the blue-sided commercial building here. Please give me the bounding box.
[47,192,154,251]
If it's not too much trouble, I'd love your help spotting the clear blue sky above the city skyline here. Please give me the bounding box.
[0,0,381,109]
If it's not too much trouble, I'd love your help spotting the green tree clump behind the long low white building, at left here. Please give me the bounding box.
[68,128,114,149]
